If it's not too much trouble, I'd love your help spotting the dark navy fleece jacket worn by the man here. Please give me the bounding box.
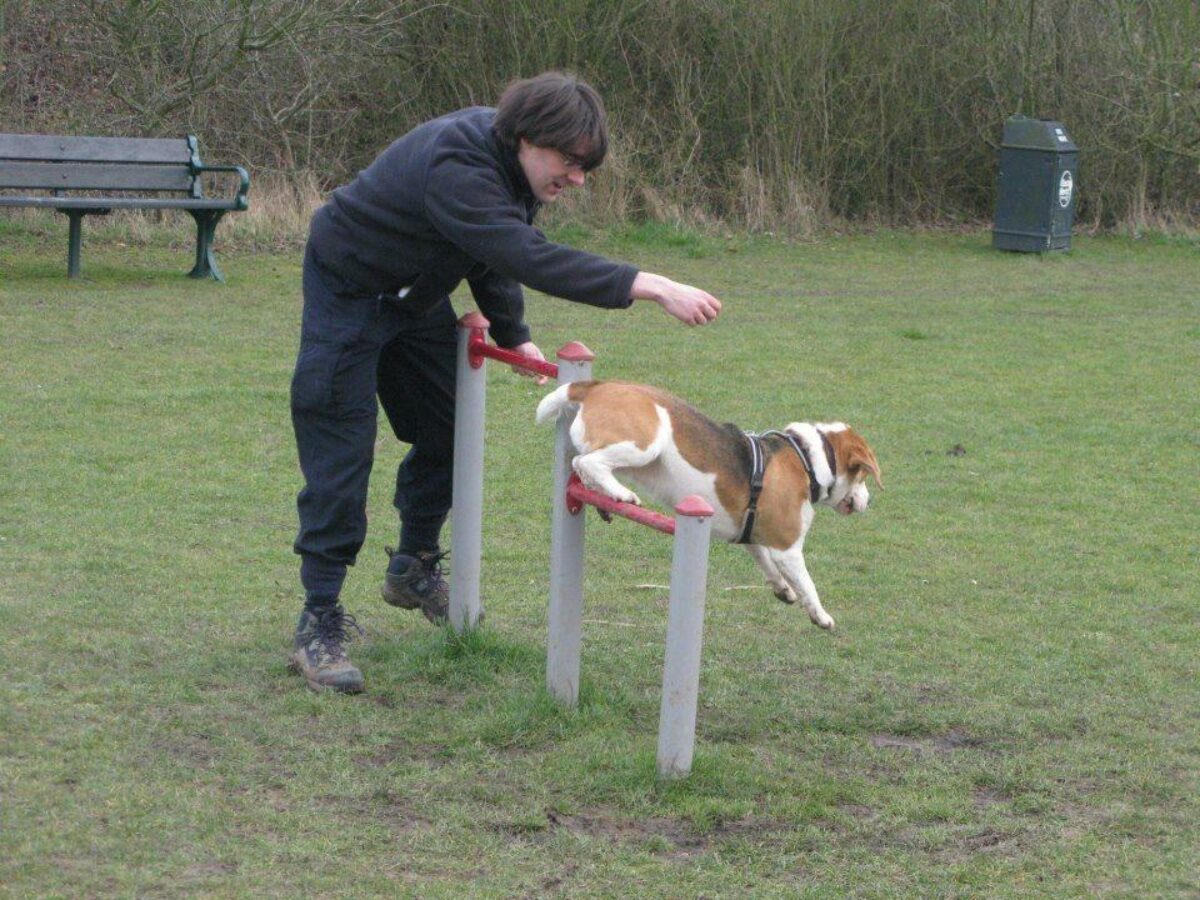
[310,107,637,347]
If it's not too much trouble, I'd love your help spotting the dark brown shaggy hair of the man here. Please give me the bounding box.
[494,72,608,172]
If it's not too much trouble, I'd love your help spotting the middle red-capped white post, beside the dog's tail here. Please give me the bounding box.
[546,341,594,707]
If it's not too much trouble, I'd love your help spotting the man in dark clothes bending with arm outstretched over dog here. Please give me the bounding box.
[292,72,721,692]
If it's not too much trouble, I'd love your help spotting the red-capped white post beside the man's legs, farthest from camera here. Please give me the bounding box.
[450,312,488,634]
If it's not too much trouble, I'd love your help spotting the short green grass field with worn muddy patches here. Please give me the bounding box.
[0,223,1200,898]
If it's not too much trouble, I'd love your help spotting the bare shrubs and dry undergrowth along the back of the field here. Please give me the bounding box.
[0,0,1200,232]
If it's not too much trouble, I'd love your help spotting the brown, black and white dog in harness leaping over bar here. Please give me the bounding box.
[536,380,883,629]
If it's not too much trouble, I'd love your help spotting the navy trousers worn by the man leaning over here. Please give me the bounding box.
[292,247,457,602]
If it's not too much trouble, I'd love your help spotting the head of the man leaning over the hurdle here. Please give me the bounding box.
[494,72,608,203]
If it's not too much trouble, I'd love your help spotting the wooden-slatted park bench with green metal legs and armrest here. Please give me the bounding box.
[0,134,250,281]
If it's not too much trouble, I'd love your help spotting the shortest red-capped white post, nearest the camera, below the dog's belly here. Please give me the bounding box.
[658,494,713,778]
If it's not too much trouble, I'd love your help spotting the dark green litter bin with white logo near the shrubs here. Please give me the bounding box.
[991,115,1079,253]
